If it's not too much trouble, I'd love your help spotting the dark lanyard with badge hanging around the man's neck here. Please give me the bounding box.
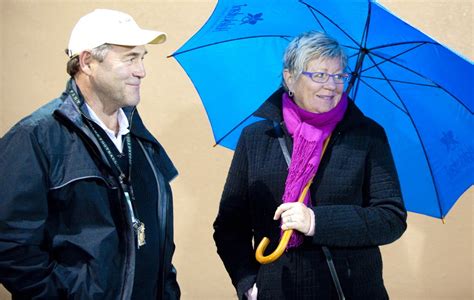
[68,88,146,248]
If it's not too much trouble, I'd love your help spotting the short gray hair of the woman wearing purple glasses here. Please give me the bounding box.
[282,31,347,90]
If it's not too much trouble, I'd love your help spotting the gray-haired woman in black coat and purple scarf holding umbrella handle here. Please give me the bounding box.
[214,32,406,299]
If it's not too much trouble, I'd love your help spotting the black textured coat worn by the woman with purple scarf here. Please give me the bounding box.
[214,89,407,299]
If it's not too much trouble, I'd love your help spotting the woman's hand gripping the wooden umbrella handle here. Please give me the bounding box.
[273,202,315,235]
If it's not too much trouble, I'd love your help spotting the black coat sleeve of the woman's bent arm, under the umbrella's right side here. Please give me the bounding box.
[312,125,407,247]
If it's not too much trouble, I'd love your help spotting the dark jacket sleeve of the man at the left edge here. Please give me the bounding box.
[0,126,74,299]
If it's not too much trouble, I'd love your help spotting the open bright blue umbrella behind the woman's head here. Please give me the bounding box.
[173,0,474,218]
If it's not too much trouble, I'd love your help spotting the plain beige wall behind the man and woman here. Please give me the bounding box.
[0,0,474,299]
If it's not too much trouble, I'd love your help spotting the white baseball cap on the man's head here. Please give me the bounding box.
[66,9,166,57]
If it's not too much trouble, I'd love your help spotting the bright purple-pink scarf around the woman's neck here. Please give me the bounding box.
[282,93,347,249]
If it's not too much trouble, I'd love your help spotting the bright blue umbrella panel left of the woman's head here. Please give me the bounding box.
[176,38,287,146]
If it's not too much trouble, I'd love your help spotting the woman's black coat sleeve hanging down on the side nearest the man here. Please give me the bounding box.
[214,130,259,299]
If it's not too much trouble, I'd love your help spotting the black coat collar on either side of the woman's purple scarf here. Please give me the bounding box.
[253,87,368,131]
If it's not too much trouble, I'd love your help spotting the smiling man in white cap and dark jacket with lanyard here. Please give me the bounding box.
[0,9,180,299]
